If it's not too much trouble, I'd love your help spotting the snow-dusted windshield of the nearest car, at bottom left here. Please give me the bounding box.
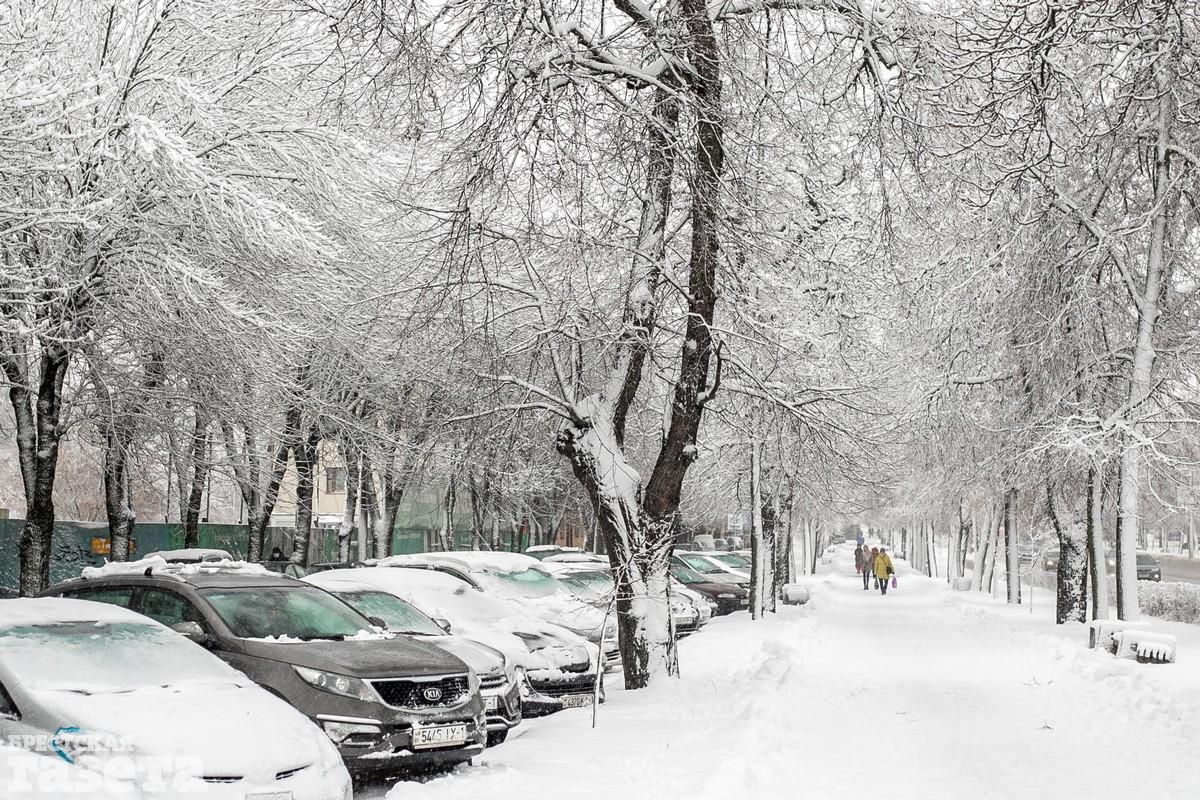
[0,620,241,694]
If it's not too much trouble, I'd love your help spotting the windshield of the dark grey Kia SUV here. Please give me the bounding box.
[202,584,371,640]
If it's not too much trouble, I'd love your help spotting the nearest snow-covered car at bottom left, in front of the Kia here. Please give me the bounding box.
[0,597,350,800]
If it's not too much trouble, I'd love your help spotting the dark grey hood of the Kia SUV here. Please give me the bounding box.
[242,636,467,678]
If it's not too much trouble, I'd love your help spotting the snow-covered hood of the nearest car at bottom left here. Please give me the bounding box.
[35,684,336,782]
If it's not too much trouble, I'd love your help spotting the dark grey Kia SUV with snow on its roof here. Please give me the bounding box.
[43,567,487,775]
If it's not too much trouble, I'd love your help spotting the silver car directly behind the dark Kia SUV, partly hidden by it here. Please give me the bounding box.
[310,572,521,747]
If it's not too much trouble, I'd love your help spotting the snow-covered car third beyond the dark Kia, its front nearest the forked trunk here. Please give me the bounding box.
[379,551,620,668]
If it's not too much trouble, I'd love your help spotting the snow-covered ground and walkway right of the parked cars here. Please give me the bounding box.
[362,548,1200,800]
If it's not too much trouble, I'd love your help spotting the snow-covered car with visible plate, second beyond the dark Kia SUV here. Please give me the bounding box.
[305,566,604,716]
